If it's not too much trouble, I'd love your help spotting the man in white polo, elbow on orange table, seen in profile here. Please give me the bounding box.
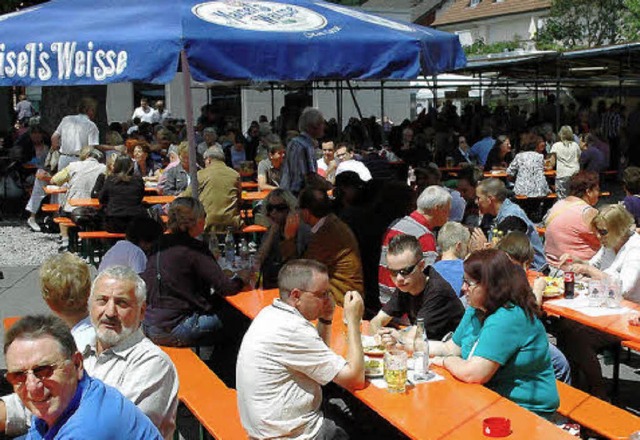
[236,260,364,439]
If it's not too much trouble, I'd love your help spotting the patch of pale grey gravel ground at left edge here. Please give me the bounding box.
[0,220,59,267]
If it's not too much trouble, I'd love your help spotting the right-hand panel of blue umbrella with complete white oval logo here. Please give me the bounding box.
[182,0,466,81]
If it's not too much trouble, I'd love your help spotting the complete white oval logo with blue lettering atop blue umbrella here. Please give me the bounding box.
[191,0,327,32]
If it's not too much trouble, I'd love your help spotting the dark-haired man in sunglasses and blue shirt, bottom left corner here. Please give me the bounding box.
[4,315,162,440]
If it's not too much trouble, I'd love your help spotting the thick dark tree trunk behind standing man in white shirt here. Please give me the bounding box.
[40,86,108,143]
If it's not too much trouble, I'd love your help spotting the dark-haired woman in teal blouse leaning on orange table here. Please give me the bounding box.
[429,249,560,417]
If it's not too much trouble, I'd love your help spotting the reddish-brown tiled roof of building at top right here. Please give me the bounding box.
[432,0,551,27]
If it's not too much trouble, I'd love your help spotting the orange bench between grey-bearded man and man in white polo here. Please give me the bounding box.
[161,347,247,440]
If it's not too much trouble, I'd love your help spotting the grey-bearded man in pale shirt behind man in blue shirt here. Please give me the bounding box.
[0,266,178,440]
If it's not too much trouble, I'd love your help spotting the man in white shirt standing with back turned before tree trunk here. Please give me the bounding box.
[51,98,100,170]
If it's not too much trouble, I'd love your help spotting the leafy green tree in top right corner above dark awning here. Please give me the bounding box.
[536,0,640,49]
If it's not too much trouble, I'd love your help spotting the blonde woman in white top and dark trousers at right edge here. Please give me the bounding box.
[558,205,640,399]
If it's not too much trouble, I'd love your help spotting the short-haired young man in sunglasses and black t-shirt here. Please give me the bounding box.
[369,234,464,344]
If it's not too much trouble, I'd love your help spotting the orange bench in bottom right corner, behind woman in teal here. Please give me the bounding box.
[556,381,640,439]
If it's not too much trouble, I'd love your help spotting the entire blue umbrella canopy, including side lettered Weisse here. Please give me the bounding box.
[0,0,466,86]
